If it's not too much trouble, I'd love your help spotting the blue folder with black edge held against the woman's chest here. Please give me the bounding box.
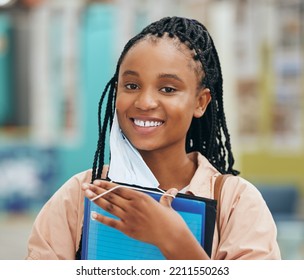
[81,183,215,260]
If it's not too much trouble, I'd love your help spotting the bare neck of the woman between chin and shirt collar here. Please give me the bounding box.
[140,148,197,190]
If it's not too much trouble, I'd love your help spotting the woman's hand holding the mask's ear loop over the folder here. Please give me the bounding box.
[83,180,210,259]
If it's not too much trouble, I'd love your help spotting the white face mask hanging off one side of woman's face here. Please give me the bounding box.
[108,112,159,188]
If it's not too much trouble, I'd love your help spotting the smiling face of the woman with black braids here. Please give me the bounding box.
[116,38,210,155]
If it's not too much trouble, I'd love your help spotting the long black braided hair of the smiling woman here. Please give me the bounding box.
[92,17,239,181]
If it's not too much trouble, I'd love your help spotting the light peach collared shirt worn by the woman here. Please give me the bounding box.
[26,153,281,260]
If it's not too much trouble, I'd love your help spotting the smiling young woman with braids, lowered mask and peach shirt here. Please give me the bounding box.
[27,17,280,259]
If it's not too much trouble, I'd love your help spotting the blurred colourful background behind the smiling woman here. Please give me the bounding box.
[0,0,304,259]
